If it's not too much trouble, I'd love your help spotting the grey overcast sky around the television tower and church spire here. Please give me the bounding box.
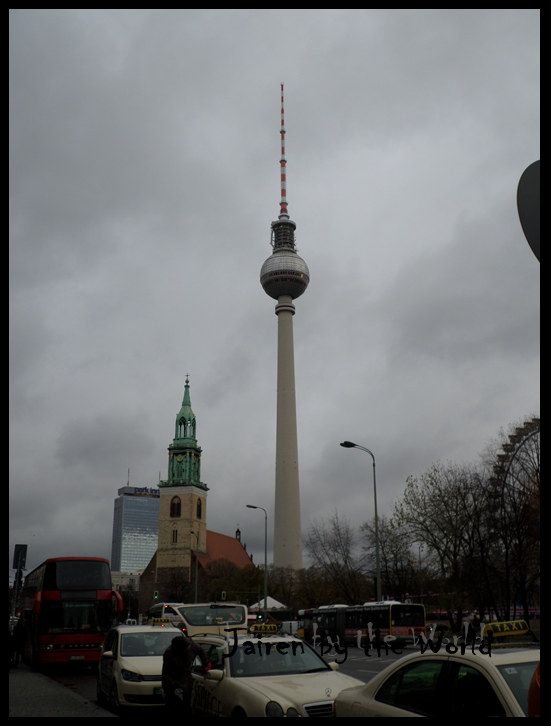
[9,9,540,584]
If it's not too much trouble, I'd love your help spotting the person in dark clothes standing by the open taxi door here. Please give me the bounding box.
[163,635,208,716]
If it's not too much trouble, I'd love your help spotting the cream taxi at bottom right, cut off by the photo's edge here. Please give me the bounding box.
[333,649,540,721]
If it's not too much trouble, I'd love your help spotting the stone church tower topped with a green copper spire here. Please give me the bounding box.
[156,377,208,589]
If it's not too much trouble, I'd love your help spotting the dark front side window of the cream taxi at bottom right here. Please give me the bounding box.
[375,660,446,716]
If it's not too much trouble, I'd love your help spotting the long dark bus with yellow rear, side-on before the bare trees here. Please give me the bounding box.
[297,600,426,647]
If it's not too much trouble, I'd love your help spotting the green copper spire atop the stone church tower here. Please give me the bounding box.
[159,376,208,491]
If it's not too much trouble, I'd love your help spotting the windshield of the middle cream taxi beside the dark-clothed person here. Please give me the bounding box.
[230,640,331,678]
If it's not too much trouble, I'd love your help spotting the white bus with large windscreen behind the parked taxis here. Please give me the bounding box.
[147,601,248,637]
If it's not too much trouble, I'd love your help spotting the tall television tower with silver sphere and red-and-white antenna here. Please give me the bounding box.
[260,84,310,570]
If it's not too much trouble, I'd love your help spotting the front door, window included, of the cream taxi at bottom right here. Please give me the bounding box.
[366,658,448,717]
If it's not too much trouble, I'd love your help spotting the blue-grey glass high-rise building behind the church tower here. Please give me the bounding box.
[111,487,160,572]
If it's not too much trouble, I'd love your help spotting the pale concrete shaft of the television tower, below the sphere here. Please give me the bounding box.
[274,295,302,570]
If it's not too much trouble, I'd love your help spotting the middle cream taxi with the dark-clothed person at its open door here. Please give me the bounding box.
[192,625,363,717]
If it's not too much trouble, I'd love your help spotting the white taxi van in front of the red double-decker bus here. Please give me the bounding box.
[97,619,180,713]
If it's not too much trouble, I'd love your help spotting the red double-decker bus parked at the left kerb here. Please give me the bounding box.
[21,557,123,667]
